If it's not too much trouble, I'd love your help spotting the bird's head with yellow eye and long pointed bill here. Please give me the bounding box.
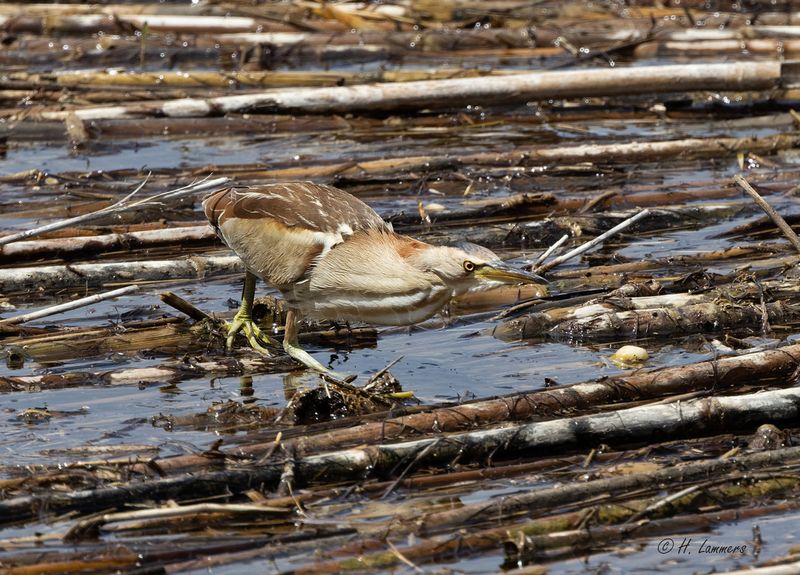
[416,242,548,295]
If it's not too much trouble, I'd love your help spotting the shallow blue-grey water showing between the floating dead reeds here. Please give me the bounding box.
[0,83,797,573]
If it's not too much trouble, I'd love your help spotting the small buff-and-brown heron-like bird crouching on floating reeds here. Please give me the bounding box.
[203,182,546,372]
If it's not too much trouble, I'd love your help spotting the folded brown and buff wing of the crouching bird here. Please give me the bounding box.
[203,182,391,287]
